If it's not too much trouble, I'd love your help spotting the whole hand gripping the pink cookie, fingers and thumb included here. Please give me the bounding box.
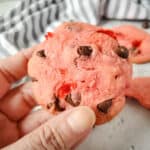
[0,49,95,150]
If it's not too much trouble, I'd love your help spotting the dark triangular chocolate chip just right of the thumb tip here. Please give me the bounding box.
[97,99,112,114]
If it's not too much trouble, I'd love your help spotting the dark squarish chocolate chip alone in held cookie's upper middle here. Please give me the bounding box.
[77,46,93,56]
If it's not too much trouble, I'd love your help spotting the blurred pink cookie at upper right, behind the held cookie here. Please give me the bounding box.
[113,25,150,63]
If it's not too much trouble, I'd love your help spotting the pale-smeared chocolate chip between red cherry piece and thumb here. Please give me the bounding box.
[65,94,81,107]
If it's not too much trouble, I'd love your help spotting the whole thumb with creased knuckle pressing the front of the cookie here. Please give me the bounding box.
[5,106,95,150]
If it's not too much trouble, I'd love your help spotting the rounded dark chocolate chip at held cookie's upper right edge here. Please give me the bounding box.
[115,46,129,59]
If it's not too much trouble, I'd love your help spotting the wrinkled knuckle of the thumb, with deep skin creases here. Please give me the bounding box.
[40,125,67,150]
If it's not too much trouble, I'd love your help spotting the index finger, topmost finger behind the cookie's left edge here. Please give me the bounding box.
[0,42,44,98]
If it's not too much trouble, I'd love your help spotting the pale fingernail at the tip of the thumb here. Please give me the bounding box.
[67,106,96,133]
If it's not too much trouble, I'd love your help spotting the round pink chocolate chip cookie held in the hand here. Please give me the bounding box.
[28,22,131,124]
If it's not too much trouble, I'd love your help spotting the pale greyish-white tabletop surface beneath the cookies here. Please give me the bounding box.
[0,0,150,150]
